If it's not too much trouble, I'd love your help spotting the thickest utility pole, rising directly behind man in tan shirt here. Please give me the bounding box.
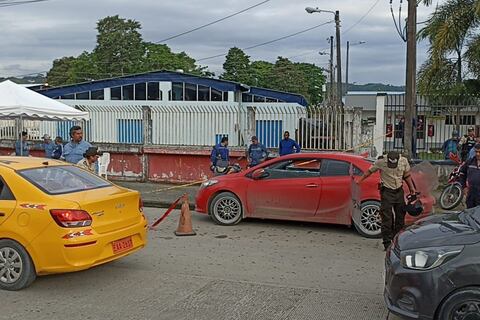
[403,0,417,158]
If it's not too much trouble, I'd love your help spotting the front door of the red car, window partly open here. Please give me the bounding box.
[247,158,321,220]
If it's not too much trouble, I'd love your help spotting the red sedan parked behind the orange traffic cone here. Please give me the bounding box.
[196,153,435,238]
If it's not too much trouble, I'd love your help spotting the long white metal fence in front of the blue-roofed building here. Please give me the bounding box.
[0,100,361,150]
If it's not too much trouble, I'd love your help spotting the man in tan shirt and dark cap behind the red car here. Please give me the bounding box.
[358,151,415,249]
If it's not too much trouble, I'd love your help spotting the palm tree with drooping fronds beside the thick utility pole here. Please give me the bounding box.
[418,0,480,93]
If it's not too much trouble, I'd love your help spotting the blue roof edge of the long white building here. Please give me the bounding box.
[37,71,307,106]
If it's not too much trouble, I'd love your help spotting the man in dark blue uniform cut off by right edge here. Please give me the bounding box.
[460,143,480,208]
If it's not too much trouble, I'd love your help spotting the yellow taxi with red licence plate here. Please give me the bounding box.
[0,157,147,290]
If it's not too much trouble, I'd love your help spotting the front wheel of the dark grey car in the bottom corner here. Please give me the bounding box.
[437,287,480,320]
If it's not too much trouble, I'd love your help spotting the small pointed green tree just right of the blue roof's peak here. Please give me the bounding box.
[220,47,252,84]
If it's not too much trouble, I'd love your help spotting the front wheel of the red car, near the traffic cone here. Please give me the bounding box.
[210,192,243,226]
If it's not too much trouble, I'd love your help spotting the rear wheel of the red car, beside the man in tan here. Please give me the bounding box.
[353,201,382,238]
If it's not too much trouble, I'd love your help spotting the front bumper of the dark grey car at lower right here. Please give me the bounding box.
[384,249,454,320]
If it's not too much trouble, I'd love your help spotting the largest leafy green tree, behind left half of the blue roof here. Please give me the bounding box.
[47,15,208,86]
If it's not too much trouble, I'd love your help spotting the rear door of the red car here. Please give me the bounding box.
[315,159,353,224]
